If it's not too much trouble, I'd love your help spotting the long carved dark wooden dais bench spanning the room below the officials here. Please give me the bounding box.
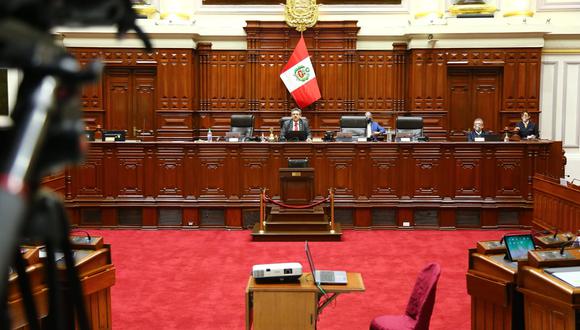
[65,141,563,228]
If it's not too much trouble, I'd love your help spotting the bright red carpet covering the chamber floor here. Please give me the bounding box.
[86,230,503,330]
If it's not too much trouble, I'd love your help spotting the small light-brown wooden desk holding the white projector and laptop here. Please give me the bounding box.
[246,272,365,330]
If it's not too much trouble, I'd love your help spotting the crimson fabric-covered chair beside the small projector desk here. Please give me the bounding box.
[371,264,441,330]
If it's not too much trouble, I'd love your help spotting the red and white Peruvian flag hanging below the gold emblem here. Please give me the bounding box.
[280,37,320,108]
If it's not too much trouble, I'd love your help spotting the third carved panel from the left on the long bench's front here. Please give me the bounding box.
[154,146,187,200]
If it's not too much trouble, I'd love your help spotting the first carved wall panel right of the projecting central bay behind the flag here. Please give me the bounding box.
[356,51,400,111]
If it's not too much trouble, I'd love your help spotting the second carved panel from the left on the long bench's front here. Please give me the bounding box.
[115,146,146,198]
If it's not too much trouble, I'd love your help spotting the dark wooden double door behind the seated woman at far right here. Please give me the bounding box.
[448,69,501,138]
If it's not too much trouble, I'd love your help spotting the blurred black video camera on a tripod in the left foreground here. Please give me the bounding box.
[0,0,151,329]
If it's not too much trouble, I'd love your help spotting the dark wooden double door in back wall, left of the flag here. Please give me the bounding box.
[104,68,155,139]
